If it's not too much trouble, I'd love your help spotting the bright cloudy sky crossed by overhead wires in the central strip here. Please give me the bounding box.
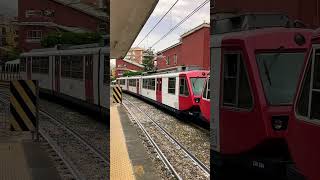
[133,0,210,51]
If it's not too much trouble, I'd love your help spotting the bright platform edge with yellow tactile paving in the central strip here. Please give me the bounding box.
[110,104,160,180]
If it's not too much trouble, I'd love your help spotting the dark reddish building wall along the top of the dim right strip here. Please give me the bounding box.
[211,0,320,28]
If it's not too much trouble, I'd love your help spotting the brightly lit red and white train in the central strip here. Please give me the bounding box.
[117,70,209,120]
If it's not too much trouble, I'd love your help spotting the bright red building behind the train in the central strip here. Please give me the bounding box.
[155,23,210,70]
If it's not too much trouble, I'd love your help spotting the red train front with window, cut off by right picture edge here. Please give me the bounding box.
[288,46,320,180]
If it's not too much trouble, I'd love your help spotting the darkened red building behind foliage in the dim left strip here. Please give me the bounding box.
[18,0,109,51]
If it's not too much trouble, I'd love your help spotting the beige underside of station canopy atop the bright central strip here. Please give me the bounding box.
[110,0,158,58]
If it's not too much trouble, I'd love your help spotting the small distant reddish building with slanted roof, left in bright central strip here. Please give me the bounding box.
[115,59,144,78]
